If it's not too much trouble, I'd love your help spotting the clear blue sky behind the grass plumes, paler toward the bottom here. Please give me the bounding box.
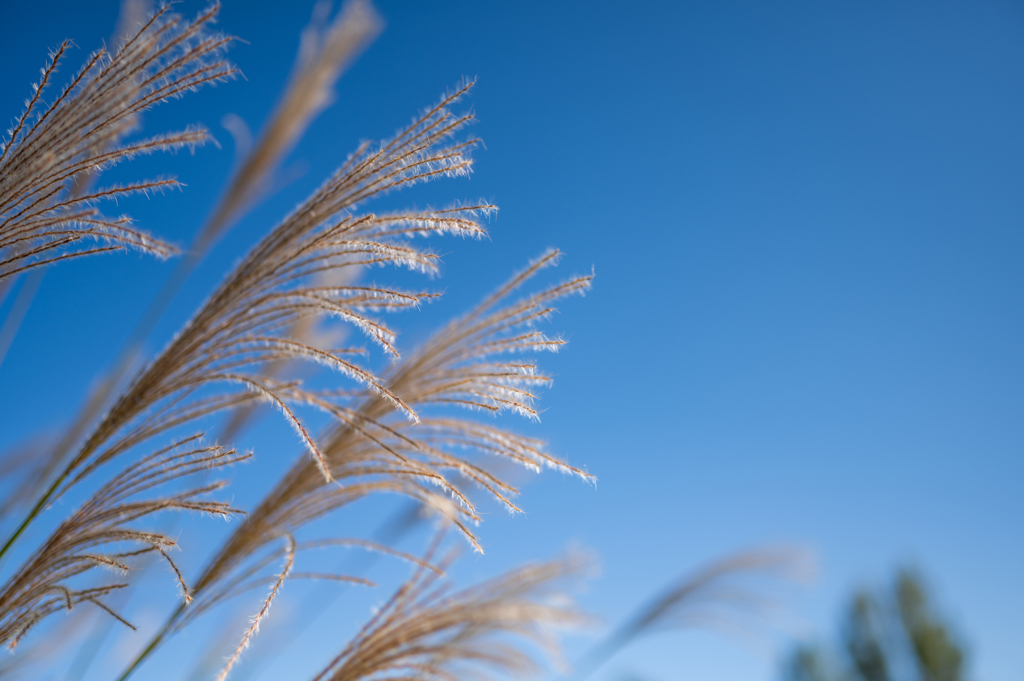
[0,0,1024,681]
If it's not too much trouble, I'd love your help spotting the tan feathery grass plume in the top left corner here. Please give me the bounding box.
[0,5,236,281]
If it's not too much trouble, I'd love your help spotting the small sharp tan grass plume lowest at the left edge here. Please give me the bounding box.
[0,435,250,647]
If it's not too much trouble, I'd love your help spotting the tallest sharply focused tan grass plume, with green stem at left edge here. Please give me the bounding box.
[0,83,489,655]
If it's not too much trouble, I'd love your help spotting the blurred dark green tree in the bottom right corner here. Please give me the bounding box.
[782,570,965,681]
